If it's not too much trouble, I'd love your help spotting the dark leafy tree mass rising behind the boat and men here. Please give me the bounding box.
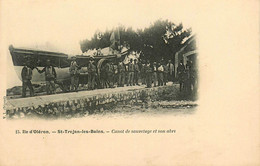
[80,19,192,61]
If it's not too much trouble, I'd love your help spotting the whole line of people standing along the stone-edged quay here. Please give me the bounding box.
[21,57,196,97]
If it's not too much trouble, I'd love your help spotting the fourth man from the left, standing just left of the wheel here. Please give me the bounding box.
[88,58,97,90]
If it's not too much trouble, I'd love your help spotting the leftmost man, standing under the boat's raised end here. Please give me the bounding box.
[21,61,34,97]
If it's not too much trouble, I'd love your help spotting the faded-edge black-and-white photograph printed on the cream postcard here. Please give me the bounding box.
[4,2,199,119]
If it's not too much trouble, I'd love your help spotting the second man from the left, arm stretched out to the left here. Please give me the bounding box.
[36,59,57,95]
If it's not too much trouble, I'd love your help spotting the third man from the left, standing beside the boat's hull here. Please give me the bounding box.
[69,57,79,92]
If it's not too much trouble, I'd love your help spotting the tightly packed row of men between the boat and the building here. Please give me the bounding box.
[101,59,174,88]
